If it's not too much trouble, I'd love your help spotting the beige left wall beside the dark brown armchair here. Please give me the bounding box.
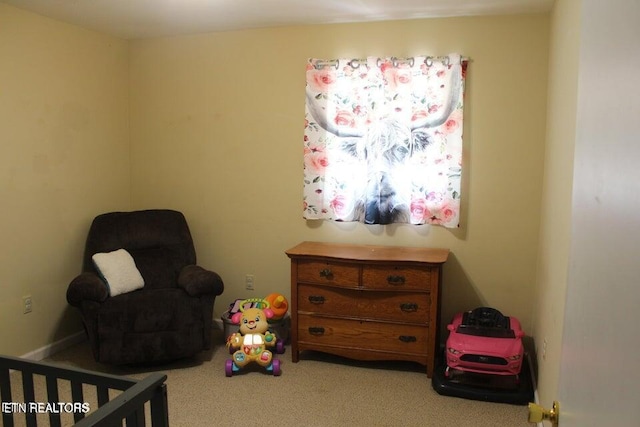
[0,4,130,355]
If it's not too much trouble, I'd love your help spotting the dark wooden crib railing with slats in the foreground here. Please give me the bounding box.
[0,356,169,427]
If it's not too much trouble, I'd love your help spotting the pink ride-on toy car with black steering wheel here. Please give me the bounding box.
[445,307,524,381]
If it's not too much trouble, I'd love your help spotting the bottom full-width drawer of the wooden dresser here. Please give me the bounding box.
[298,313,429,355]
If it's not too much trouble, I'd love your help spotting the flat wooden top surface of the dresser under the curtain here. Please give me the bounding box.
[285,242,449,264]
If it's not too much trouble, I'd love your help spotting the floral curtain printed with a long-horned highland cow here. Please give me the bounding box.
[304,54,467,227]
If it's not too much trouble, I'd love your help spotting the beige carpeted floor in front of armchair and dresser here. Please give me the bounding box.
[8,331,532,427]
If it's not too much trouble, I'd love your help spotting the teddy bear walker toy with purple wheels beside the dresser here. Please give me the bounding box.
[225,302,281,377]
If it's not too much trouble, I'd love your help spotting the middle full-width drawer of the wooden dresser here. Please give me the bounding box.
[298,285,431,325]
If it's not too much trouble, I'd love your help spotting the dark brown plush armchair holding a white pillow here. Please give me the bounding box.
[67,210,224,364]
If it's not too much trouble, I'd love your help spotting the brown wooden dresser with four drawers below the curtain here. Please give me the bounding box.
[286,242,449,377]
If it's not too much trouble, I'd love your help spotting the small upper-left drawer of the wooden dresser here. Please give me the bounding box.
[298,260,360,287]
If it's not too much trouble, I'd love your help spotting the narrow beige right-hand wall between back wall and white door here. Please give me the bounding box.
[533,0,581,407]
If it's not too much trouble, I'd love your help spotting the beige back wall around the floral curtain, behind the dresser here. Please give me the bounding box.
[130,15,549,332]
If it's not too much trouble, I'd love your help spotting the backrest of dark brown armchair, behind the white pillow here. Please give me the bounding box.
[83,209,196,289]
